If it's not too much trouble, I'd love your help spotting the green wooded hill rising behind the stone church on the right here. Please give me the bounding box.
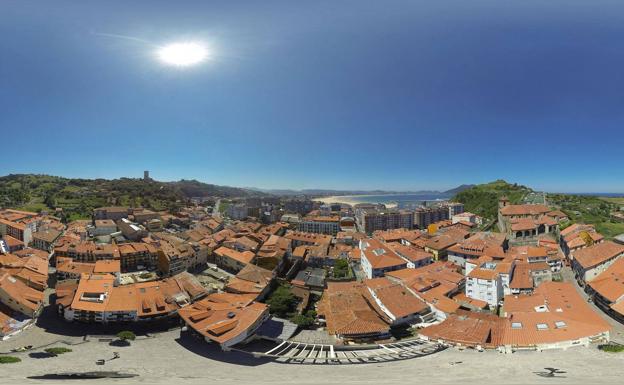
[453,179,533,219]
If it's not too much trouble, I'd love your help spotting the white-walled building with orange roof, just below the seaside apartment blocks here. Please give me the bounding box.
[359,238,407,279]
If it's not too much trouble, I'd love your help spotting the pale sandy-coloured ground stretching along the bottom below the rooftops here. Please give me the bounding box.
[0,330,624,384]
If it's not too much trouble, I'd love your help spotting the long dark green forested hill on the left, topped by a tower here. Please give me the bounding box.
[0,174,264,218]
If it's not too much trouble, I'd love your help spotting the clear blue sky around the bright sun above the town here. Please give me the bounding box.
[0,0,624,192]
